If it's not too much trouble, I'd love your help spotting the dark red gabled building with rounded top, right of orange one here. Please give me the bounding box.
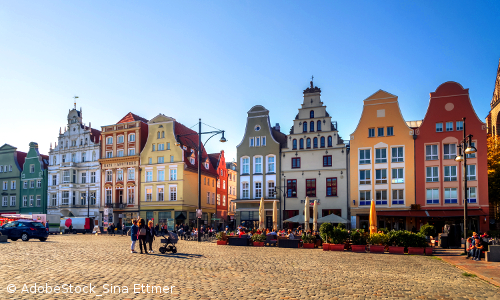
[413,82,489,236]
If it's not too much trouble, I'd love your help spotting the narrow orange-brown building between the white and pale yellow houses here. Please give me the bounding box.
[99,112,148,227]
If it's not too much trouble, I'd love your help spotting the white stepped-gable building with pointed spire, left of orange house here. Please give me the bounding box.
[281,81,349,225]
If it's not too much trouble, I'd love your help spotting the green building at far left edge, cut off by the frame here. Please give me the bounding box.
[0,144,26,214]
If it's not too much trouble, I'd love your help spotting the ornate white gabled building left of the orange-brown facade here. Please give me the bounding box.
[47,106,101,221]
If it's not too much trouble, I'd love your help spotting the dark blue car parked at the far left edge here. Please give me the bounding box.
[0,220,49,242]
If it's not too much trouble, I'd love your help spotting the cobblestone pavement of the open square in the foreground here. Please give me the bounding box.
[0,234,500,299]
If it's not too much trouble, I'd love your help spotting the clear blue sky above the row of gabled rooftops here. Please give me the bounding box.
[0,0,500,161]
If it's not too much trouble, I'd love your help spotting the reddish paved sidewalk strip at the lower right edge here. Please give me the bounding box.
[434,248,500,287]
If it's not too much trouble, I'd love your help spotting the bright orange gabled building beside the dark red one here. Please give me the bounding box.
[349,90,415,230]
